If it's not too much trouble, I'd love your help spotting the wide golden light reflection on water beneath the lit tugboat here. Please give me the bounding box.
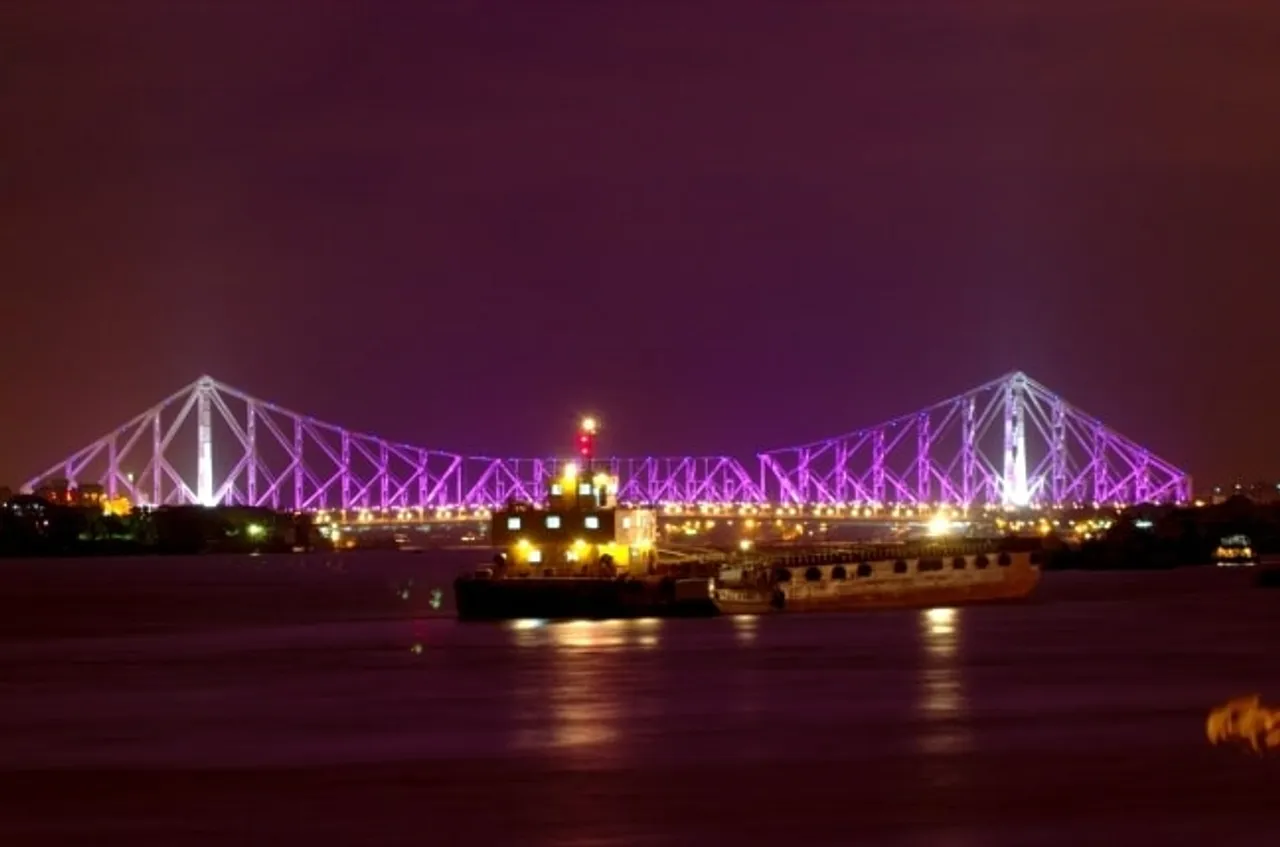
[508,618,662,766]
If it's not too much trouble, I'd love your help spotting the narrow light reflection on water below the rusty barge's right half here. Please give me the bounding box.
[919,609,973,754]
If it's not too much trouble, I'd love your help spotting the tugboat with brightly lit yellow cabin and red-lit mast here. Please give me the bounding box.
[453,418,718,621]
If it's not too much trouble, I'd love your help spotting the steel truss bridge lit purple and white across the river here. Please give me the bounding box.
[24,372,1190,513]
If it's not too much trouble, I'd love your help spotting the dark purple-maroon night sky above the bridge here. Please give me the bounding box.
[0,0,1280,484]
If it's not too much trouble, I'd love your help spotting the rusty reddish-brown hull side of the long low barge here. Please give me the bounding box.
[716,553,1041,614]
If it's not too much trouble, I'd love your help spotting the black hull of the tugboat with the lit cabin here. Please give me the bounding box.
[453,577,719,621]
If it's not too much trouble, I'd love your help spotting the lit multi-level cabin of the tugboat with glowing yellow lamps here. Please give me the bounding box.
[490,464,658,578]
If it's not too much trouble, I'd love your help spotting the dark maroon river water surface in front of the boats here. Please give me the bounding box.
[0,554,1280,847]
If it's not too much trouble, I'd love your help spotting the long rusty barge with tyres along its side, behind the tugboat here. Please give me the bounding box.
[713,541,1041,614]
